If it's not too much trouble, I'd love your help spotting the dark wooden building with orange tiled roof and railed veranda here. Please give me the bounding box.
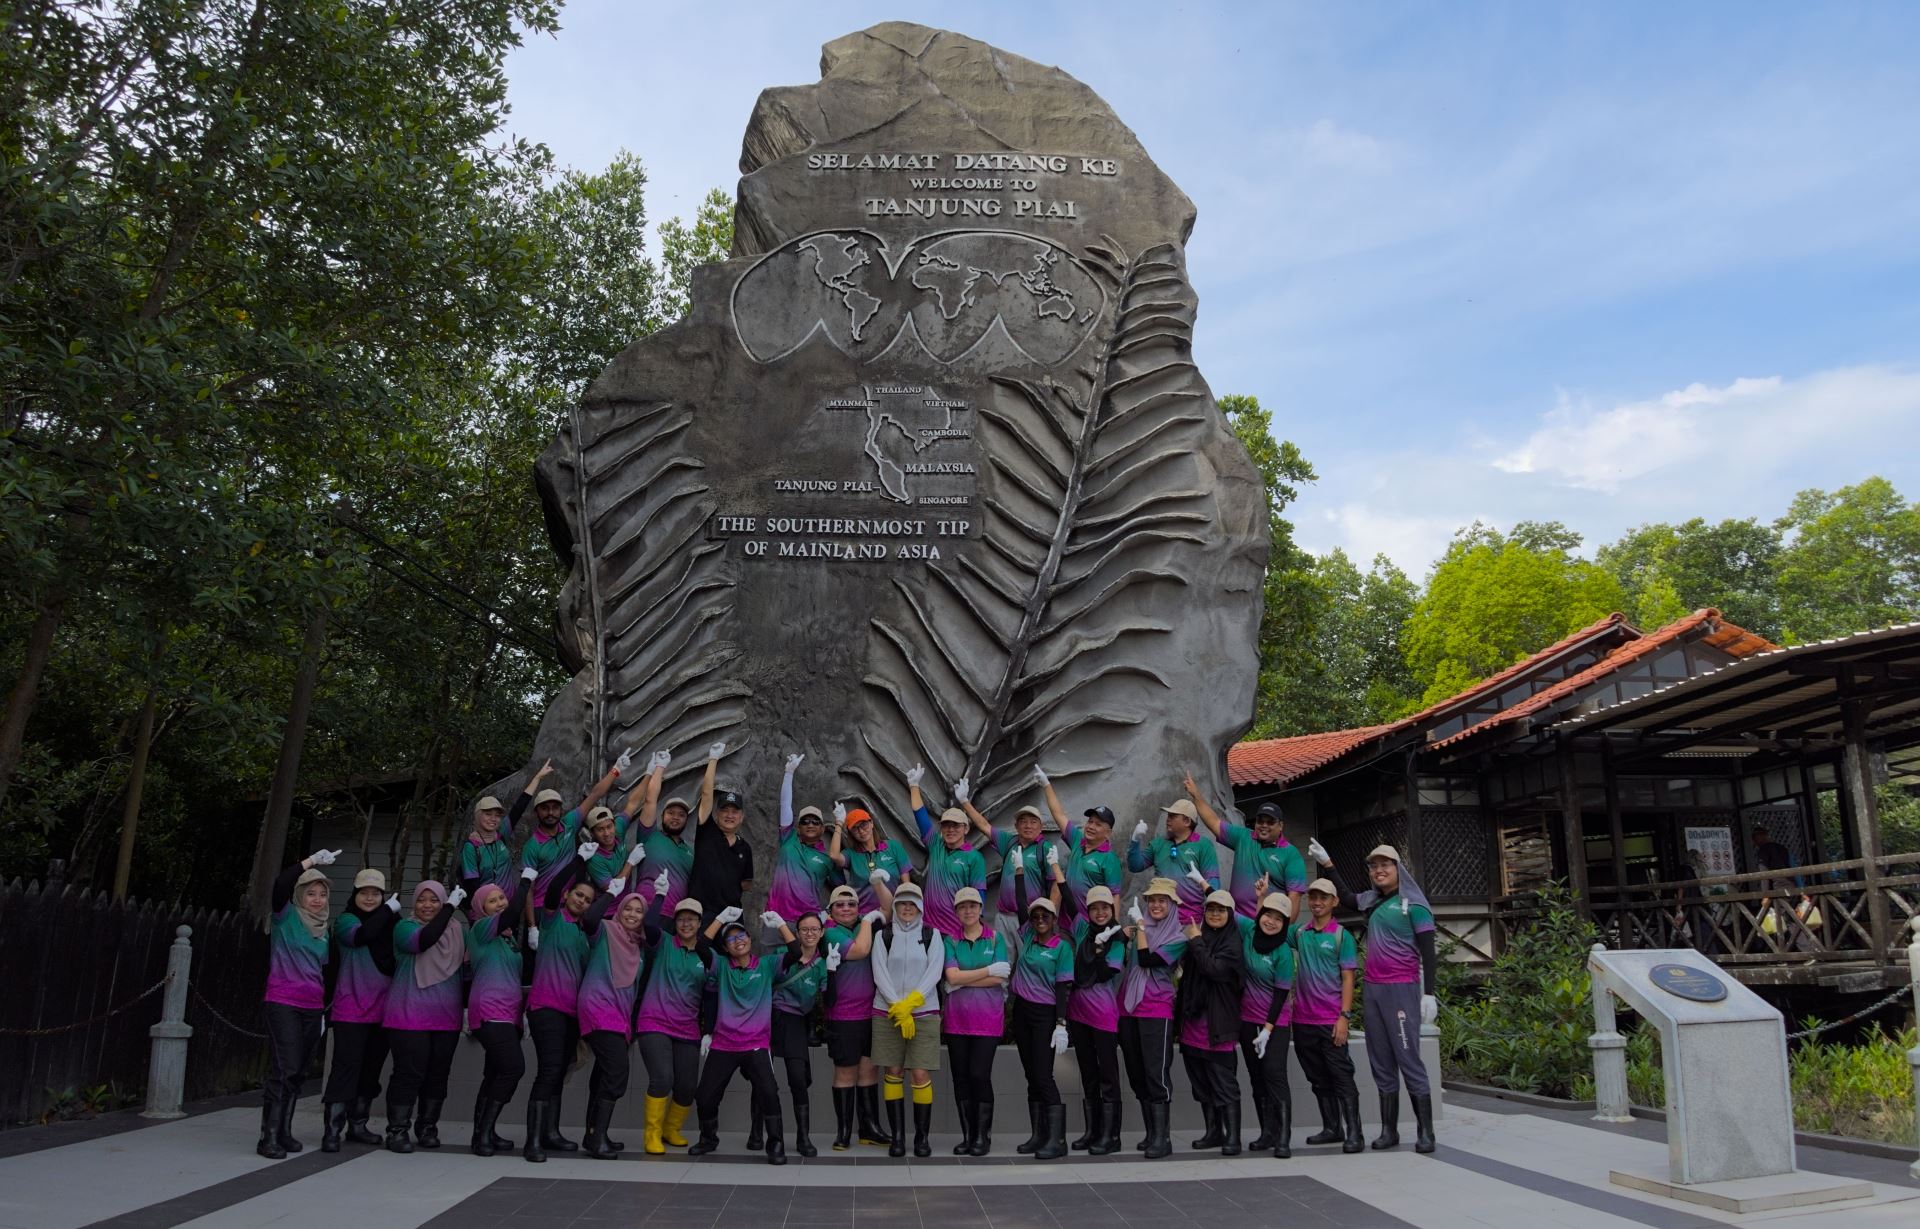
[1229,609,1920,991]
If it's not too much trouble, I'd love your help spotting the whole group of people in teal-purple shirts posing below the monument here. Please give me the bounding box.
[257,743,1436,1164]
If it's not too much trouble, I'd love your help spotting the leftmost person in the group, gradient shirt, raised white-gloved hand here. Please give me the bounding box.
[253,849,340,1160]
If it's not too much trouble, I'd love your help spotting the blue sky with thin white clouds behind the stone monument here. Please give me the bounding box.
[509,0,1920,576]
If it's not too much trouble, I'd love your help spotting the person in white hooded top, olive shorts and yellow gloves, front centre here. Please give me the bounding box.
[872,883,947,1156]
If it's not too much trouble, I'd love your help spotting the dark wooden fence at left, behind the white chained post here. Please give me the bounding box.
[0,880,267,1125]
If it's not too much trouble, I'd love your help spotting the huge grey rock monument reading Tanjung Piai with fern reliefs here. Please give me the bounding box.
[501,23,1267,875]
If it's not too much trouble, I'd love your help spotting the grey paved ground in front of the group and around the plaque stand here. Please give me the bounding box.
[0,1095,1920,1229]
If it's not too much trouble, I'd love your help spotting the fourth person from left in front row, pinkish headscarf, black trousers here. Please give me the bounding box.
[467,866,538,1156]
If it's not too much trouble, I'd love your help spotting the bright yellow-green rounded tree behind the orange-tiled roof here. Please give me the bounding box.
[1405,522,1626,705]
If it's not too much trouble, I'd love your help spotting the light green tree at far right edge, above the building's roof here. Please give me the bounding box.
[1774,478,1920,643]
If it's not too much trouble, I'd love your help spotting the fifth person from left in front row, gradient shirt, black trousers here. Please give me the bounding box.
[520,843,599,1162]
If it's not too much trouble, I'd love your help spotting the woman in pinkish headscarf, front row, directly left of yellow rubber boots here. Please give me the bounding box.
[576,876,657,1160]
